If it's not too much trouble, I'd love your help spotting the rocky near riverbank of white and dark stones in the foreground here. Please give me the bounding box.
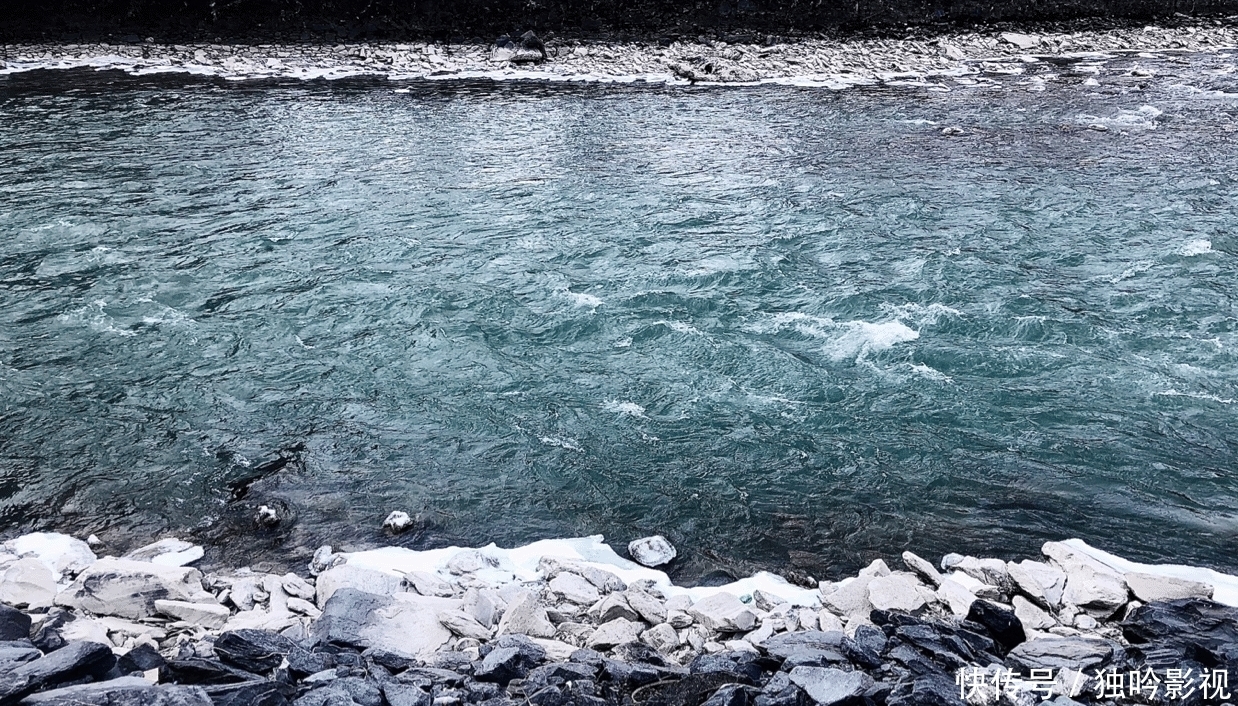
[0,534,1238,706]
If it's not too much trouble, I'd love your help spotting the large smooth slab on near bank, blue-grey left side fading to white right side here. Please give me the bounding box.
[310,588,461,659]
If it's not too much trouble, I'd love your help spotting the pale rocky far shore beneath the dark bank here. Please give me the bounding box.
[0,19,1238,88]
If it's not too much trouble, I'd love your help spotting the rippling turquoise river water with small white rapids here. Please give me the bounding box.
[0,64,1238,577]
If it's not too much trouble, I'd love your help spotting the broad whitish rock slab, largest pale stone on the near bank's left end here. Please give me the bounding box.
[56,556,214,619]
